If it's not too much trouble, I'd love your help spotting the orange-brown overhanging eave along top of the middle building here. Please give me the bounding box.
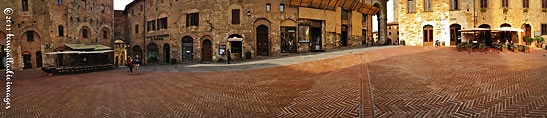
[283,0,380,15]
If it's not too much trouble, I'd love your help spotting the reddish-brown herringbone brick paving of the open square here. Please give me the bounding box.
[0,47,547,118]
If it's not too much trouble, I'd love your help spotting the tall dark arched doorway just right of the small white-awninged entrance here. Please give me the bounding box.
[256,25,269,56]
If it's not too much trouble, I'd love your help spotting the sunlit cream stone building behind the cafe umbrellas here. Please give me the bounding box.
[398,0,547,46]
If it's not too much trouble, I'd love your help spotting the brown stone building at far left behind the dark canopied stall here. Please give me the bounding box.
[0,0,114,69]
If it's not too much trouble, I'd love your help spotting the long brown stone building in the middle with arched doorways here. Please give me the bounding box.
[121,0,378,63]
